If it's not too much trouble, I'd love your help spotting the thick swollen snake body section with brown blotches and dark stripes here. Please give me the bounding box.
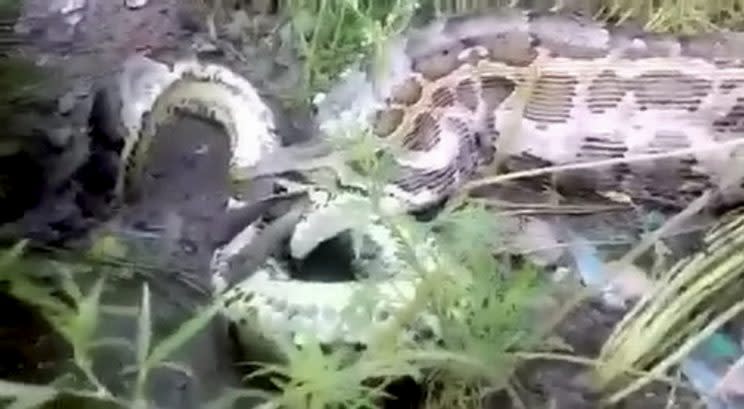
[362,11,744,208]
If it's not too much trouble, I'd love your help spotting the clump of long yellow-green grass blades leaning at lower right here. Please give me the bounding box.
[596,210,744,403]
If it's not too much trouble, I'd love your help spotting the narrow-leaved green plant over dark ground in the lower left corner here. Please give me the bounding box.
[0,242,219,409]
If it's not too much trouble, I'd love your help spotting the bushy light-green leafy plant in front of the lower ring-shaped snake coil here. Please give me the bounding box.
[230,132,546,409]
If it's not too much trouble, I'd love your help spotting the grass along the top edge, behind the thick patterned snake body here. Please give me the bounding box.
[281,0,744,101]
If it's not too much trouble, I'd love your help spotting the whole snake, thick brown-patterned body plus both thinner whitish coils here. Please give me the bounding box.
[118,9,744,356]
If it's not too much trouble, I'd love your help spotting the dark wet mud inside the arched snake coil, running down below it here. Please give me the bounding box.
[99,118,250,408]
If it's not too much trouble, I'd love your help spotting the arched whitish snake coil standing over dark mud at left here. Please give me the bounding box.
[116,56,279,202]
